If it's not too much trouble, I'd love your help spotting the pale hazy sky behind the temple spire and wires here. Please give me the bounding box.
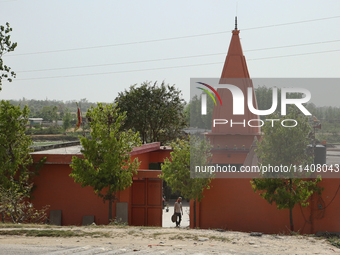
[0,0,340,106]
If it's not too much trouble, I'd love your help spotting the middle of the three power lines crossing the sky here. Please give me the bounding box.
[17,40,340,73]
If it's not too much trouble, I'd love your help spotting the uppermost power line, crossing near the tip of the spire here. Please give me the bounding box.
[7,16,340,57]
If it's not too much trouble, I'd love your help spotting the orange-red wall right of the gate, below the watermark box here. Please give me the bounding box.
[190,179,340,234]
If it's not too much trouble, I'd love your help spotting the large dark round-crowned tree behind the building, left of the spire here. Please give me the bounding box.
[115,82,185,144]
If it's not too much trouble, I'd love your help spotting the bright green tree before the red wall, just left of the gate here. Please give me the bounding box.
[70,103,141,220]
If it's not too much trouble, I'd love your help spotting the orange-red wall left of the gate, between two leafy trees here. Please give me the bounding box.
[31,164,117,225]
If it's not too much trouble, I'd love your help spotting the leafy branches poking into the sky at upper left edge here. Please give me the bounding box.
[0,22,17,90]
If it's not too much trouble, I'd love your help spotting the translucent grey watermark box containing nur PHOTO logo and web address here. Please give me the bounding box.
[187,77,340,178]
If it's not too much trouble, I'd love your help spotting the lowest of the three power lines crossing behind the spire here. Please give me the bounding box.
[16,49,340,81]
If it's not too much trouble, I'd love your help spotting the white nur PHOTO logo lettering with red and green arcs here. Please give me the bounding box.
[192,79,312,127]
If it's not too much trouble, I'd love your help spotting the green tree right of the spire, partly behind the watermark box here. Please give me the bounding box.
[251,107,321,231]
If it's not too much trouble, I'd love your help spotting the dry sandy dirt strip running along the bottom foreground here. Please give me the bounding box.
[0,227,340,255]
